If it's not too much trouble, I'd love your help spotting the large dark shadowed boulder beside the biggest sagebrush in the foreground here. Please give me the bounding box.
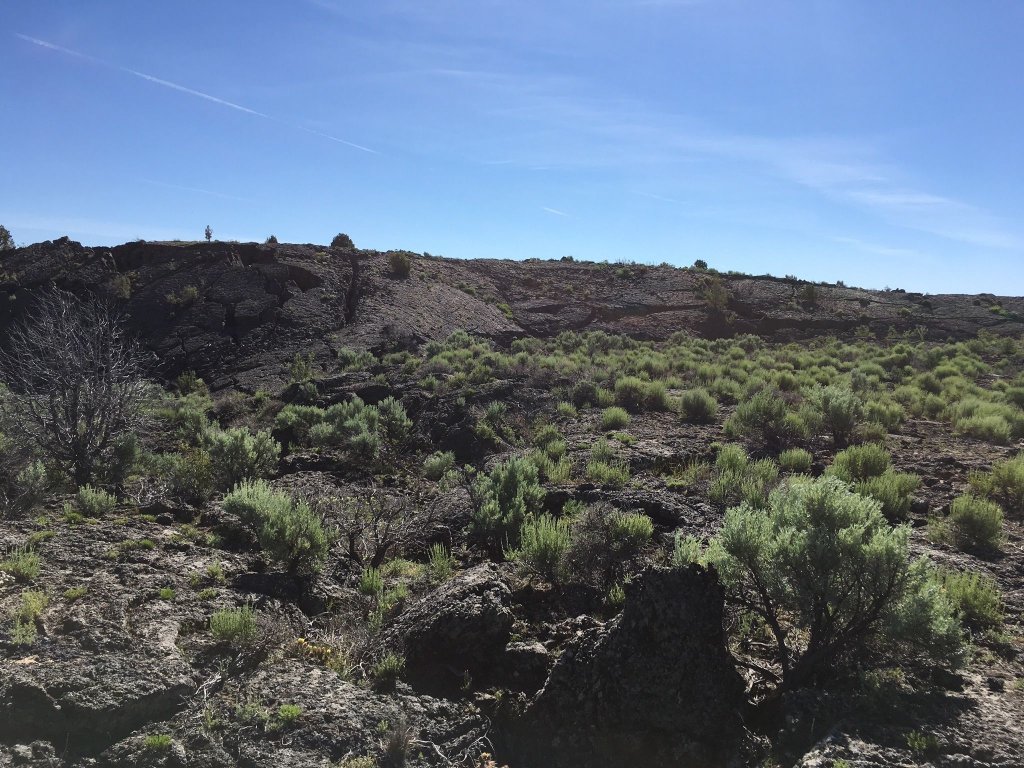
[523,565,744,768]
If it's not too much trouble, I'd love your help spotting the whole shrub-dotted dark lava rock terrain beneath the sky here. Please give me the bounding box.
[0,240,1024,768]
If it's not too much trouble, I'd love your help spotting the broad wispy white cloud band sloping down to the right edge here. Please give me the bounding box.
[468,82,1024,250]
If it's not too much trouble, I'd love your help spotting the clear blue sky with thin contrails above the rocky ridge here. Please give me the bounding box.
[0,0,1024,294]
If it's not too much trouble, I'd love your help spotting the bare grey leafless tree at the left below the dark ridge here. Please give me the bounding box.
[0,289,148,485]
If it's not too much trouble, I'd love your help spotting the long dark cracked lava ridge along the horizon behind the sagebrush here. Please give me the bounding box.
[0,239,1024,391]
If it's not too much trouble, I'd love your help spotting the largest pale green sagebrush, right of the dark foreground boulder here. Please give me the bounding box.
[677,477,964,688]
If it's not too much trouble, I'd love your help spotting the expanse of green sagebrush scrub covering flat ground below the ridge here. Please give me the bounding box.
[0,282,1024,765]
